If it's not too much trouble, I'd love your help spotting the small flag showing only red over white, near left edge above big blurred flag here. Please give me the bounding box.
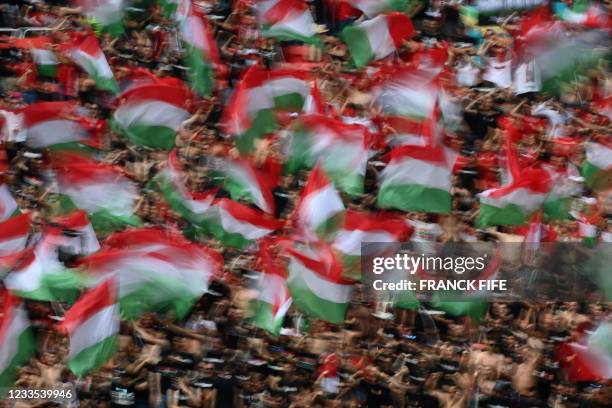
[50,210,100,255]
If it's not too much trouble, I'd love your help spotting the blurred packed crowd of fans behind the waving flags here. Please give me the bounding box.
[0,0,612,408]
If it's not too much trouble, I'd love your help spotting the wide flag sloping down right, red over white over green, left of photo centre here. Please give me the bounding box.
[201,198,283,249]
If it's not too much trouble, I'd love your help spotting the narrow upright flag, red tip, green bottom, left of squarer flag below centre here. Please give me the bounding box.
[248,245,292,336]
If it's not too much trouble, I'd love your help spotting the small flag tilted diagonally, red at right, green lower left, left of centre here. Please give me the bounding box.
[220,159,278,214]
